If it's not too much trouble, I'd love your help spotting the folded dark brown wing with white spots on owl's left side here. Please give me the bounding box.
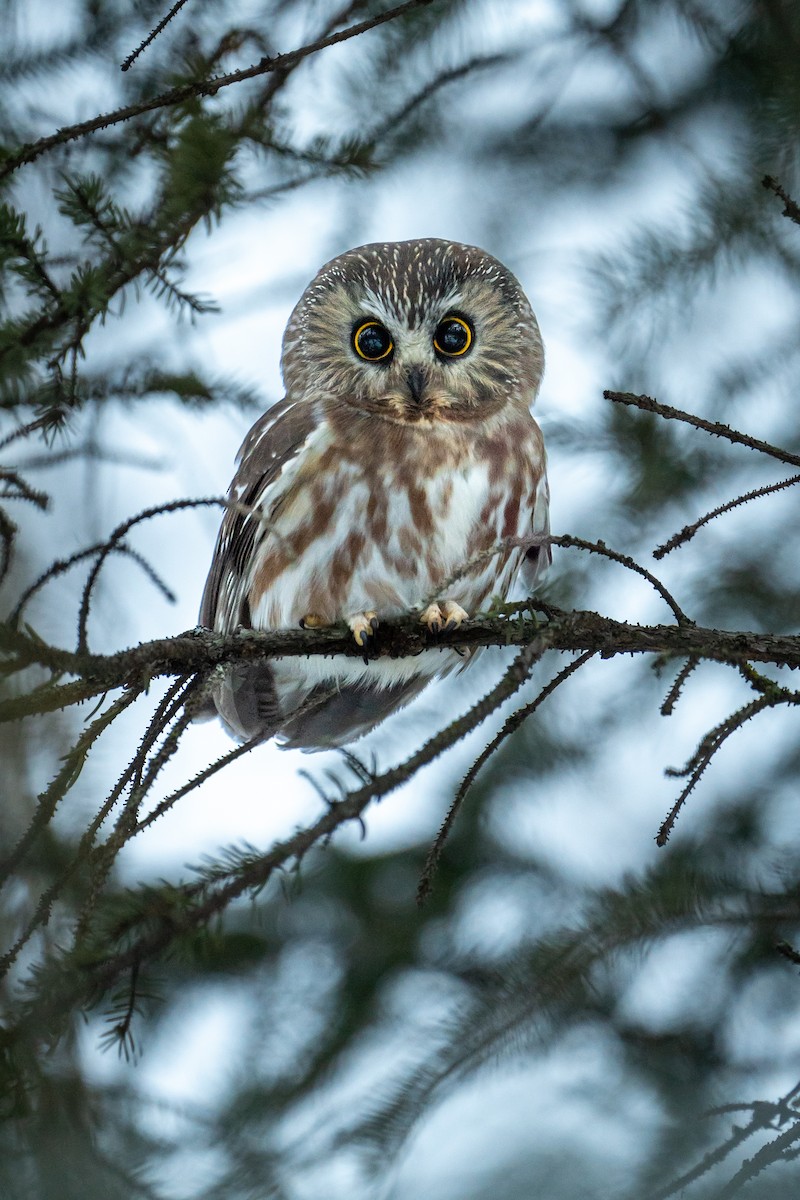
[199,397,319,632]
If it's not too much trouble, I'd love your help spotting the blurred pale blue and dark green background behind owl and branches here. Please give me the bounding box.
[0,0,800,1200]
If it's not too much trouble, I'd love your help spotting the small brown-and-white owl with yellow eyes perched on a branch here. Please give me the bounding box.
[200,239,549,750]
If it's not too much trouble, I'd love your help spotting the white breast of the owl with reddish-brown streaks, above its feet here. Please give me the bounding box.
[249,419,537,629]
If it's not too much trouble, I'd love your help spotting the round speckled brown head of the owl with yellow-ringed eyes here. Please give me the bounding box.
[282,238,543,424]
